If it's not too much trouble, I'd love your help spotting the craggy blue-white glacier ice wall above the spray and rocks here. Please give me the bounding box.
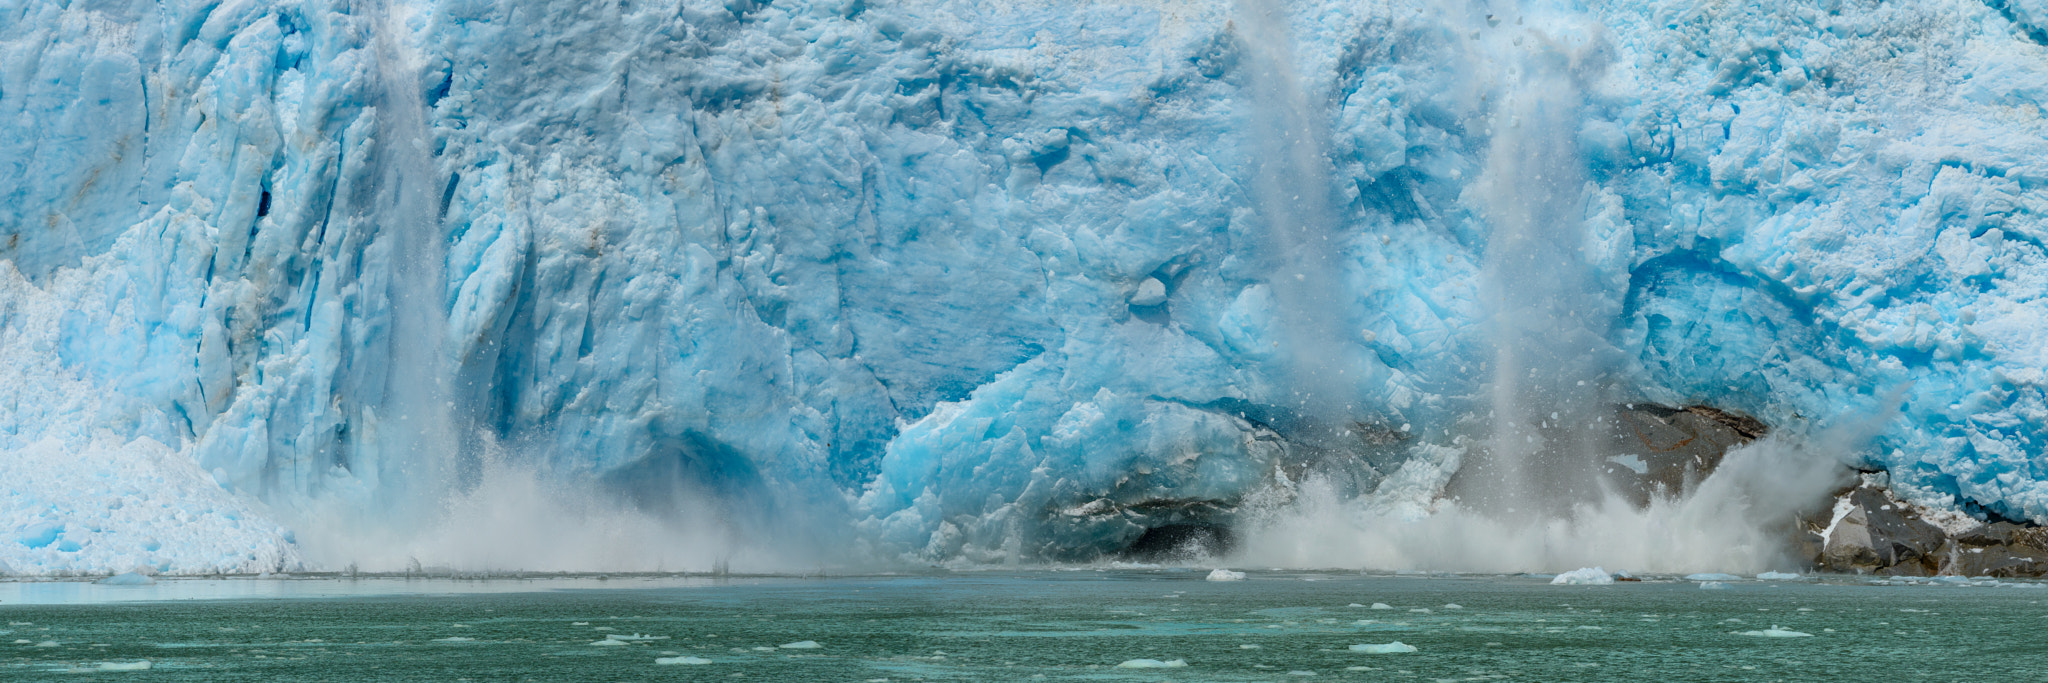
[0,0,2048,574]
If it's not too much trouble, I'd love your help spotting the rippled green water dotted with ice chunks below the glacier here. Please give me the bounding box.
[0,570,2048,681]
